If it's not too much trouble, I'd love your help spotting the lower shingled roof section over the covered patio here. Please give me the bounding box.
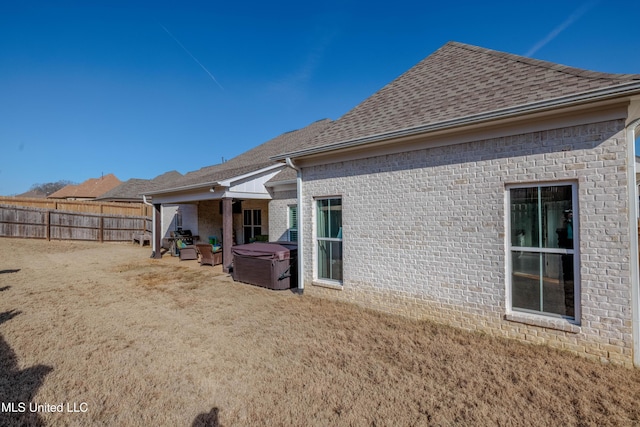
[145,119,331,194]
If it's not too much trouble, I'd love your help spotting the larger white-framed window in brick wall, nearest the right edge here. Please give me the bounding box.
[508,184,580,318]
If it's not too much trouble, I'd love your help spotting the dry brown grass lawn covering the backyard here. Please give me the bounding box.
[0,239,640,426]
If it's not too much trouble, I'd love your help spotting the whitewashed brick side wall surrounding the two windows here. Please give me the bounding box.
[302,120,632,365]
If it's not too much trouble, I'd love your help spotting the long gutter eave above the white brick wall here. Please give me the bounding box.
[271,81,640,162]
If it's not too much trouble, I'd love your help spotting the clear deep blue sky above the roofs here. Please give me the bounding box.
[0,0,640,195]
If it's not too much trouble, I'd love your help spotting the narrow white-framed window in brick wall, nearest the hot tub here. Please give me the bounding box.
[316,198,342,283]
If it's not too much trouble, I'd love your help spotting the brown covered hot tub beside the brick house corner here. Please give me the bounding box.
[231,242,298,289]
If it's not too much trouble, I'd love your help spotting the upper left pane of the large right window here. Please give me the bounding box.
[511,187,540,248]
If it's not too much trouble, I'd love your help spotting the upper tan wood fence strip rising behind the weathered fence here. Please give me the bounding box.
[0,196,153,216]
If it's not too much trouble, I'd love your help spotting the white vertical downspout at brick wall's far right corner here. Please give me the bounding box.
[626,120,640,368]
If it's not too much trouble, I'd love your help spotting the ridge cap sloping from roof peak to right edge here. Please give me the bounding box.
[448,41,640,80]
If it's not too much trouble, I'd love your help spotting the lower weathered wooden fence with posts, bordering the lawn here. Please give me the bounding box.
[0,205,151,242]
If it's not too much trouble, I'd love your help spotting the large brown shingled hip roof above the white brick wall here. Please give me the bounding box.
[274,42,640,160]
